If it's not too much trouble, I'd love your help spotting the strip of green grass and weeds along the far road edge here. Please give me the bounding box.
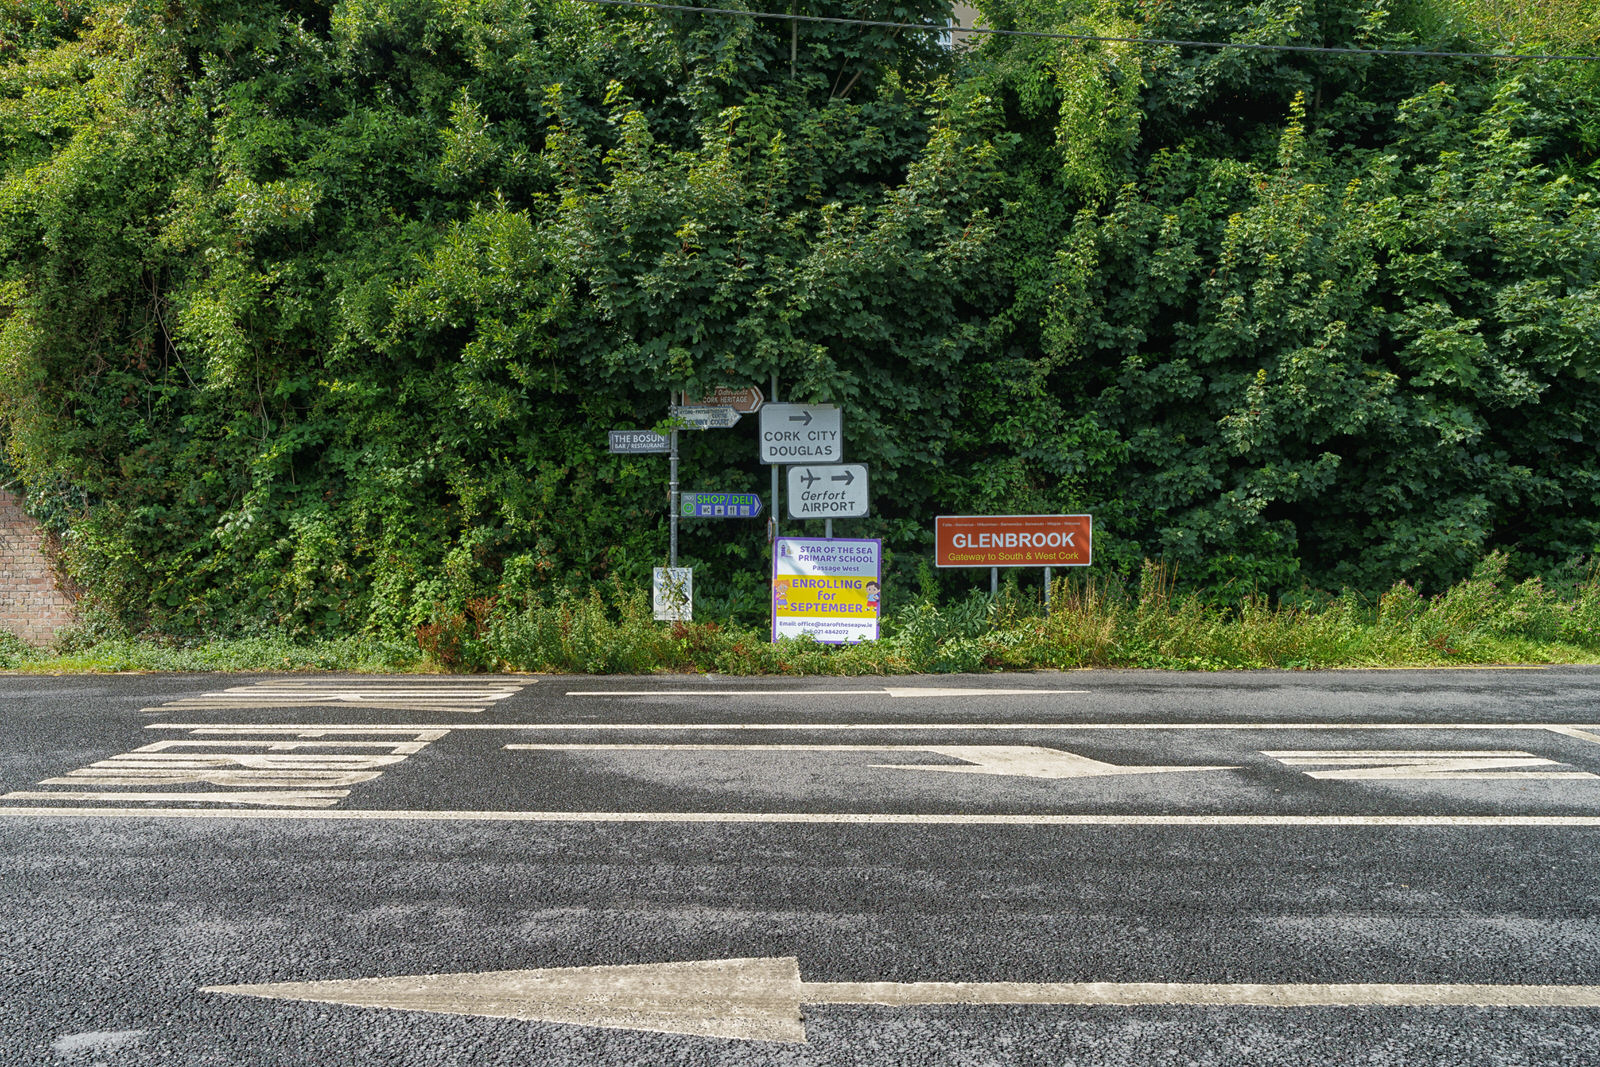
[9,555,1600,675]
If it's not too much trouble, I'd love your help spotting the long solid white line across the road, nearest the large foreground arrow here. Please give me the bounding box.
[9,812,1600,829]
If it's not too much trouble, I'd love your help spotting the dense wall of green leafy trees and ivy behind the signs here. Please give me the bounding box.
[0,0,1600,633]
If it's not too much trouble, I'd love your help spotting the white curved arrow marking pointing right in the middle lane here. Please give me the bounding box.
[506,744,1237,777]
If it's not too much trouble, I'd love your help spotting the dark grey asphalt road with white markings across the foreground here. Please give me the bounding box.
[0,669,1600,1067]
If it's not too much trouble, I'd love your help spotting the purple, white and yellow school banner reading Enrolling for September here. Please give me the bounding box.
[773,537,883,645]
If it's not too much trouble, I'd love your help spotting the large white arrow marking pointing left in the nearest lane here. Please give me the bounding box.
[200,957,1600,1043]
